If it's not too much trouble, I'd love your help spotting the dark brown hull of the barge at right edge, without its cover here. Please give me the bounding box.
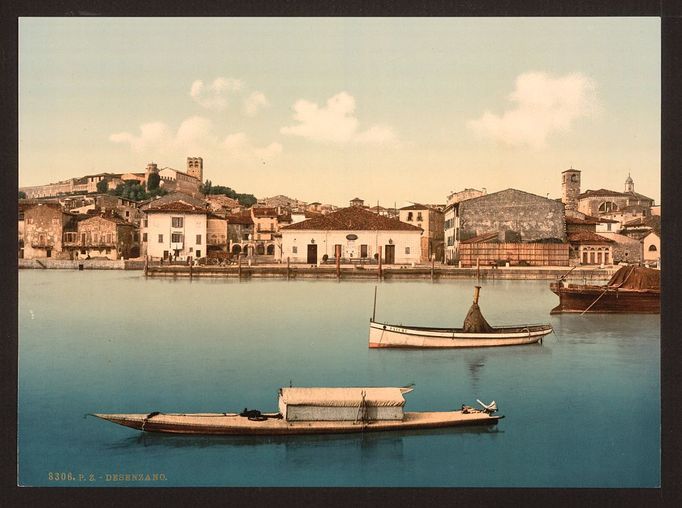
[549,282,661,314]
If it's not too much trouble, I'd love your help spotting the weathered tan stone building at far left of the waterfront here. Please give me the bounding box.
[20,203,77,259]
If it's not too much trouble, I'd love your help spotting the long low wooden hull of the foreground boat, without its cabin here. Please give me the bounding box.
[93,410,503,436]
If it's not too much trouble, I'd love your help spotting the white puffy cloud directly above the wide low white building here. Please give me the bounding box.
[280,92,396,143]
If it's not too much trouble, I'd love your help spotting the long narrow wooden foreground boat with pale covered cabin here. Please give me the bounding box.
[92,387,504,436]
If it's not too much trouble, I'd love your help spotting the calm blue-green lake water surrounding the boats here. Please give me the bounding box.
[18,270,661,487]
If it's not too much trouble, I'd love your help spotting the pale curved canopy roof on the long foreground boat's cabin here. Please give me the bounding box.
[280,387,405,407]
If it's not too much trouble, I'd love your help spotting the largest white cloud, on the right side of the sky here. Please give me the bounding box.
[467,72,599,149]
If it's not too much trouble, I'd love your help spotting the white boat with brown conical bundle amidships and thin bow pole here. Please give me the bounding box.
[369,286,552,348]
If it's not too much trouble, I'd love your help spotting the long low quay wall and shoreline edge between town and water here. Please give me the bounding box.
[18,259,619,283]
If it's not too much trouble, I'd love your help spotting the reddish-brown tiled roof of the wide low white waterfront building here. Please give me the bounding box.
[282,206,422,231]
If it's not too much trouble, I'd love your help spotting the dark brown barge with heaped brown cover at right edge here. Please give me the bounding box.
[549,265,661,314]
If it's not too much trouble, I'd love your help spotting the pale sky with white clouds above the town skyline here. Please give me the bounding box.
[19,17,661,206]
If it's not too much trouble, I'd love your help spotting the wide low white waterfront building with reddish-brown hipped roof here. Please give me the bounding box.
[281,206,422,264]
